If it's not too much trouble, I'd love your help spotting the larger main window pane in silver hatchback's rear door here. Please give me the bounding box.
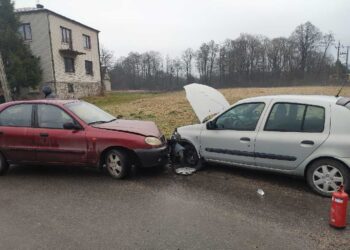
[265,103,306,132]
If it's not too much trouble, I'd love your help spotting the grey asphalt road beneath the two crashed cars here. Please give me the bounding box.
[0,164,350,249]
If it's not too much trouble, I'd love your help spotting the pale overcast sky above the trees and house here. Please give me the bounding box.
[15,0,350,57]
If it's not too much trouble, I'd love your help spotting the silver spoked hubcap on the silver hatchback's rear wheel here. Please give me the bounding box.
[312,165,344,193]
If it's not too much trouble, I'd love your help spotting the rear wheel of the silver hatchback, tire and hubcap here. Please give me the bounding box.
[306,159,350,197]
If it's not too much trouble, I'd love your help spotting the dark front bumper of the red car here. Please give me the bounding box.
[135,146,169,168]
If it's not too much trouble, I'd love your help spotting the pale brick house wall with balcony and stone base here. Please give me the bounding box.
[49,14,101,98]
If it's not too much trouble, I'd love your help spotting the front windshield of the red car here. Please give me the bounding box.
[65,102,116,125]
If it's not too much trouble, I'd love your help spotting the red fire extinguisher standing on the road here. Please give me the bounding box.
[329,185,349,228]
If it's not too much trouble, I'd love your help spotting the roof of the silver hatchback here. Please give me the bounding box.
[242,95,340,104]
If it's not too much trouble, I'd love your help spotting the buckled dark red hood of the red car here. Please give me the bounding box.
[93,119,162,138]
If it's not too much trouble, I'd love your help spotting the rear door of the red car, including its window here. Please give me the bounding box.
[0,104,36,163]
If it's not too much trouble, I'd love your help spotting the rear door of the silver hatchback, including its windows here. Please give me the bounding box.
[255,101,330,170]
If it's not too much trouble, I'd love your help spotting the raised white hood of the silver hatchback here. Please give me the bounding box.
[184,83,230,122]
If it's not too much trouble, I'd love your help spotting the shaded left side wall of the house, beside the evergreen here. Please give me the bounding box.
[19,12,54,84]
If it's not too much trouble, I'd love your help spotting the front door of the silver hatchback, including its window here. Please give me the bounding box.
[200,102,266,165]
